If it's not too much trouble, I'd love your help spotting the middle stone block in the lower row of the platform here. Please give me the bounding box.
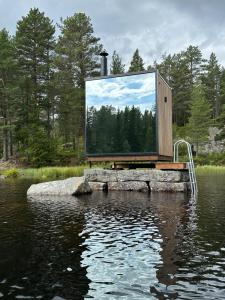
[108,181,149,192]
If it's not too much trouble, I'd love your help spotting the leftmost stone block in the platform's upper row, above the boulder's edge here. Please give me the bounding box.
[84,169,117,182]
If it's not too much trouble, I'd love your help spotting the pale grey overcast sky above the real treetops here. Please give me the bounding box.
[0,0,225,66]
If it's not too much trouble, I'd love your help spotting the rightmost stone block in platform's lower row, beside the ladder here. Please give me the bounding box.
[150,181,187,192]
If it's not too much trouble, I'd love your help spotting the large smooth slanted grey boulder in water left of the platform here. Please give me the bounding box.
[27,177,92,196]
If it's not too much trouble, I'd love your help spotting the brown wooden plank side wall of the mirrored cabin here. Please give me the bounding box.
[156,73,173,157]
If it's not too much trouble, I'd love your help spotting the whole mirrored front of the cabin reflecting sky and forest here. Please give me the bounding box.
[86,73,156,155]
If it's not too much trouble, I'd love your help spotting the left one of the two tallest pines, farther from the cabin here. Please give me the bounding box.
[15,8,55,164]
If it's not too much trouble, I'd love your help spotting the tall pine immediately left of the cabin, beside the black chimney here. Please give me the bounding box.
[55,13,102,149]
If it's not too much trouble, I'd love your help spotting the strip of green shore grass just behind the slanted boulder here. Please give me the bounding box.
[19,165,88,180]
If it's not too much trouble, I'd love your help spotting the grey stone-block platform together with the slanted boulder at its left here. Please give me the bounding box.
[27,169,189,196]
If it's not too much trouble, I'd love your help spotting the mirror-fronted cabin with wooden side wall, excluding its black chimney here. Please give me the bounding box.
[85,71,173,162]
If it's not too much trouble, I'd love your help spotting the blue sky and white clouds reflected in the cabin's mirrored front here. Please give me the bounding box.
[86,73,155,112]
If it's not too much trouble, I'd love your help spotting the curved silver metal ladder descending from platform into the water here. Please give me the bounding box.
[173,140,198,197]
